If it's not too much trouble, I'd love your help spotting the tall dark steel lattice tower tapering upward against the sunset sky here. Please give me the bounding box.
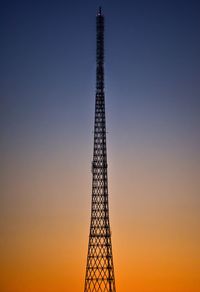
[84,8,116,292]
